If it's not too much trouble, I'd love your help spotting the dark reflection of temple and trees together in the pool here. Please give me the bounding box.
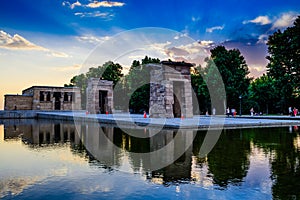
[3,120,300,199]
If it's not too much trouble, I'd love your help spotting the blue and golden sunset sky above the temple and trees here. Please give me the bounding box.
[0,0,300,109]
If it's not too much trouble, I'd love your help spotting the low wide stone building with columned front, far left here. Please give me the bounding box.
[4,86,81,110]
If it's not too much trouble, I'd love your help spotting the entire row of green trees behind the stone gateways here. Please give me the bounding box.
[65,16,300,114]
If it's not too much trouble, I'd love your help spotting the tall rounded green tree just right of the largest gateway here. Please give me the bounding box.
[204,46,252,112]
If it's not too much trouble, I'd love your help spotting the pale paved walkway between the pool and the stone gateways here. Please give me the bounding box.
[38,112,300,129]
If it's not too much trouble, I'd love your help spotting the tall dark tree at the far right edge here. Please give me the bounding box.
[266,16,300,112]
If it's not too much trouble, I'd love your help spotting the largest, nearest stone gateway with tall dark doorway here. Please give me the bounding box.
[147,61,193,118]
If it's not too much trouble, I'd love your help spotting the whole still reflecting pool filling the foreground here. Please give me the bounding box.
[0,120,300,199]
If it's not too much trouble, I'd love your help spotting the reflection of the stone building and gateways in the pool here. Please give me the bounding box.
[4,120,196,182]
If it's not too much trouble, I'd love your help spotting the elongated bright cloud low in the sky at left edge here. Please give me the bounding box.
[0,30,69,58]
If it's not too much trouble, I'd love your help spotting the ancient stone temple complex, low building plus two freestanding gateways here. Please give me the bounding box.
[4,61,193,118]
